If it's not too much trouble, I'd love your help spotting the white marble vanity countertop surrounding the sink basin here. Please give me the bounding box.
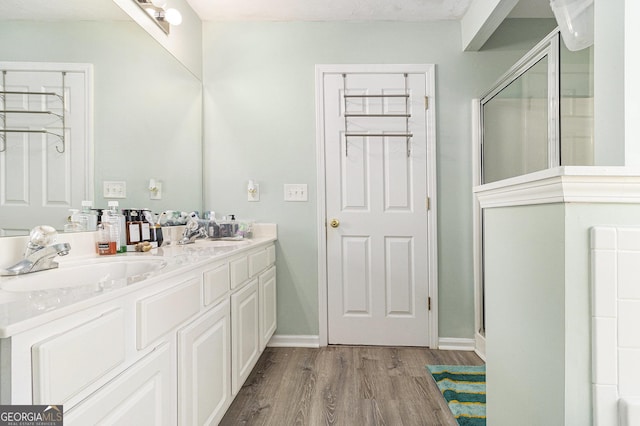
[0,225,277,338]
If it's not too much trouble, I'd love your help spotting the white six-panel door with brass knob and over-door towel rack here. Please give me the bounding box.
[324,68,430,346]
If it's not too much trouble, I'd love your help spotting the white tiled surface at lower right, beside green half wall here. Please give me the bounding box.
[591,226,640,426]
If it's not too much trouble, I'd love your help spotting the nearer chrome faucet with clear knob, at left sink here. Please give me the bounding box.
[0,226,71,276]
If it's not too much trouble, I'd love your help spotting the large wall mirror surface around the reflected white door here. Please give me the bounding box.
[0,0,203,236]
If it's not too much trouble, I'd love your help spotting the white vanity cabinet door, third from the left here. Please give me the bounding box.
[231,279,260,395]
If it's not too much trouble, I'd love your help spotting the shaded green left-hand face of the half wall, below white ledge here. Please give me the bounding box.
[484,204,568,426]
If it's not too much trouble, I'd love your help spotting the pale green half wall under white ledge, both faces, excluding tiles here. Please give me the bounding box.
[484,203,640,426]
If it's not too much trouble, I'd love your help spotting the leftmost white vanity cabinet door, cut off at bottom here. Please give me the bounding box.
[64,343,176,426]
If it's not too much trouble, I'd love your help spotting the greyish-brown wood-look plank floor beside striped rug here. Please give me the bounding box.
[220,346,483,426]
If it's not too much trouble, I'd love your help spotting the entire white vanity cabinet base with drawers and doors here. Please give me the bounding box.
[0,238,276,426]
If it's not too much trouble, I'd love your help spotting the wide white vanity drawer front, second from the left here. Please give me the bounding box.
[136,278,200,349]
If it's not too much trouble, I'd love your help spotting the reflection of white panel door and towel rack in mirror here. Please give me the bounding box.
[0,63,93,235]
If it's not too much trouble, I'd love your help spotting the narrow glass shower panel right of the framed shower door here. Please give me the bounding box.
[560,43,594,166]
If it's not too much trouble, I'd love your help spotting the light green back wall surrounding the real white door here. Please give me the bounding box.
[203,20,553,338]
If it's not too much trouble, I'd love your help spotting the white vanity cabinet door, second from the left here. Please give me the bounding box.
[178,300,231,425]
